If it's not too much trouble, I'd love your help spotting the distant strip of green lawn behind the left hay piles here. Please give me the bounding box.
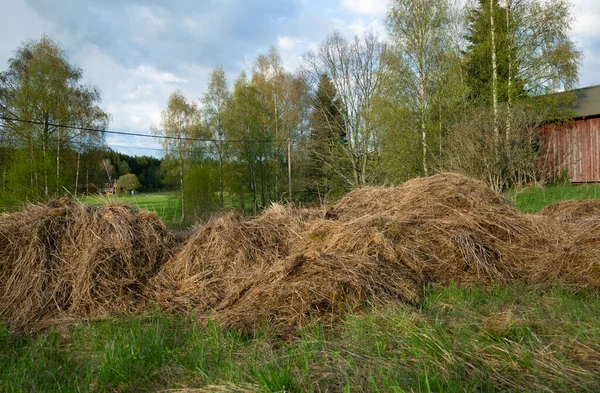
[79,191,181,223]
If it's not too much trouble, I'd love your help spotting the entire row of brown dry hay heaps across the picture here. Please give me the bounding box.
[0,173,600,334]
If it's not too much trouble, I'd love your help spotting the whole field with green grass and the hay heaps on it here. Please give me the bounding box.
[0,174,600,393]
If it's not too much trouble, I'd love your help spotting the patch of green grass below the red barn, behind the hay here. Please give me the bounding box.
[505,184,600,213]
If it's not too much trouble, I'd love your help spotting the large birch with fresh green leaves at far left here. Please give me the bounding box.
[0,36,108,197]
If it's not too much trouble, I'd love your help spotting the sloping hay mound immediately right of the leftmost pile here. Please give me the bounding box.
[152,204,322,312]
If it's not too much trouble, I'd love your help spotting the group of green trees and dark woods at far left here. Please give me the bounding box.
[0,36,164,208]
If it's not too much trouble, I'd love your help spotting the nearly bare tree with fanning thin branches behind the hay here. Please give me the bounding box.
[303,31,387,187]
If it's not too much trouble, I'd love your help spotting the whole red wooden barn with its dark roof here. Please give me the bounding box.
[540,85,600,183]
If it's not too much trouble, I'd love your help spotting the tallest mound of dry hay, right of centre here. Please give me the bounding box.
[323,173,560,285]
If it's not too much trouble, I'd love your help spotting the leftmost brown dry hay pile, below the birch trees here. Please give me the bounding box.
[0,199,172,331]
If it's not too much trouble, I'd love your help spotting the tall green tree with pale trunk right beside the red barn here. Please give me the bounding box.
[466,0,581,183]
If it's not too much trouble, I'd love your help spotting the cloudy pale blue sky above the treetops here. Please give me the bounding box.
[0,0,600,156]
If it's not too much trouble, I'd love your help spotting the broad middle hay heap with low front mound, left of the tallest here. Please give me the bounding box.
[153,205,416,333]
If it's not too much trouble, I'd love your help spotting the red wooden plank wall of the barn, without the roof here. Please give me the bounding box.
[540,117,600,183]
